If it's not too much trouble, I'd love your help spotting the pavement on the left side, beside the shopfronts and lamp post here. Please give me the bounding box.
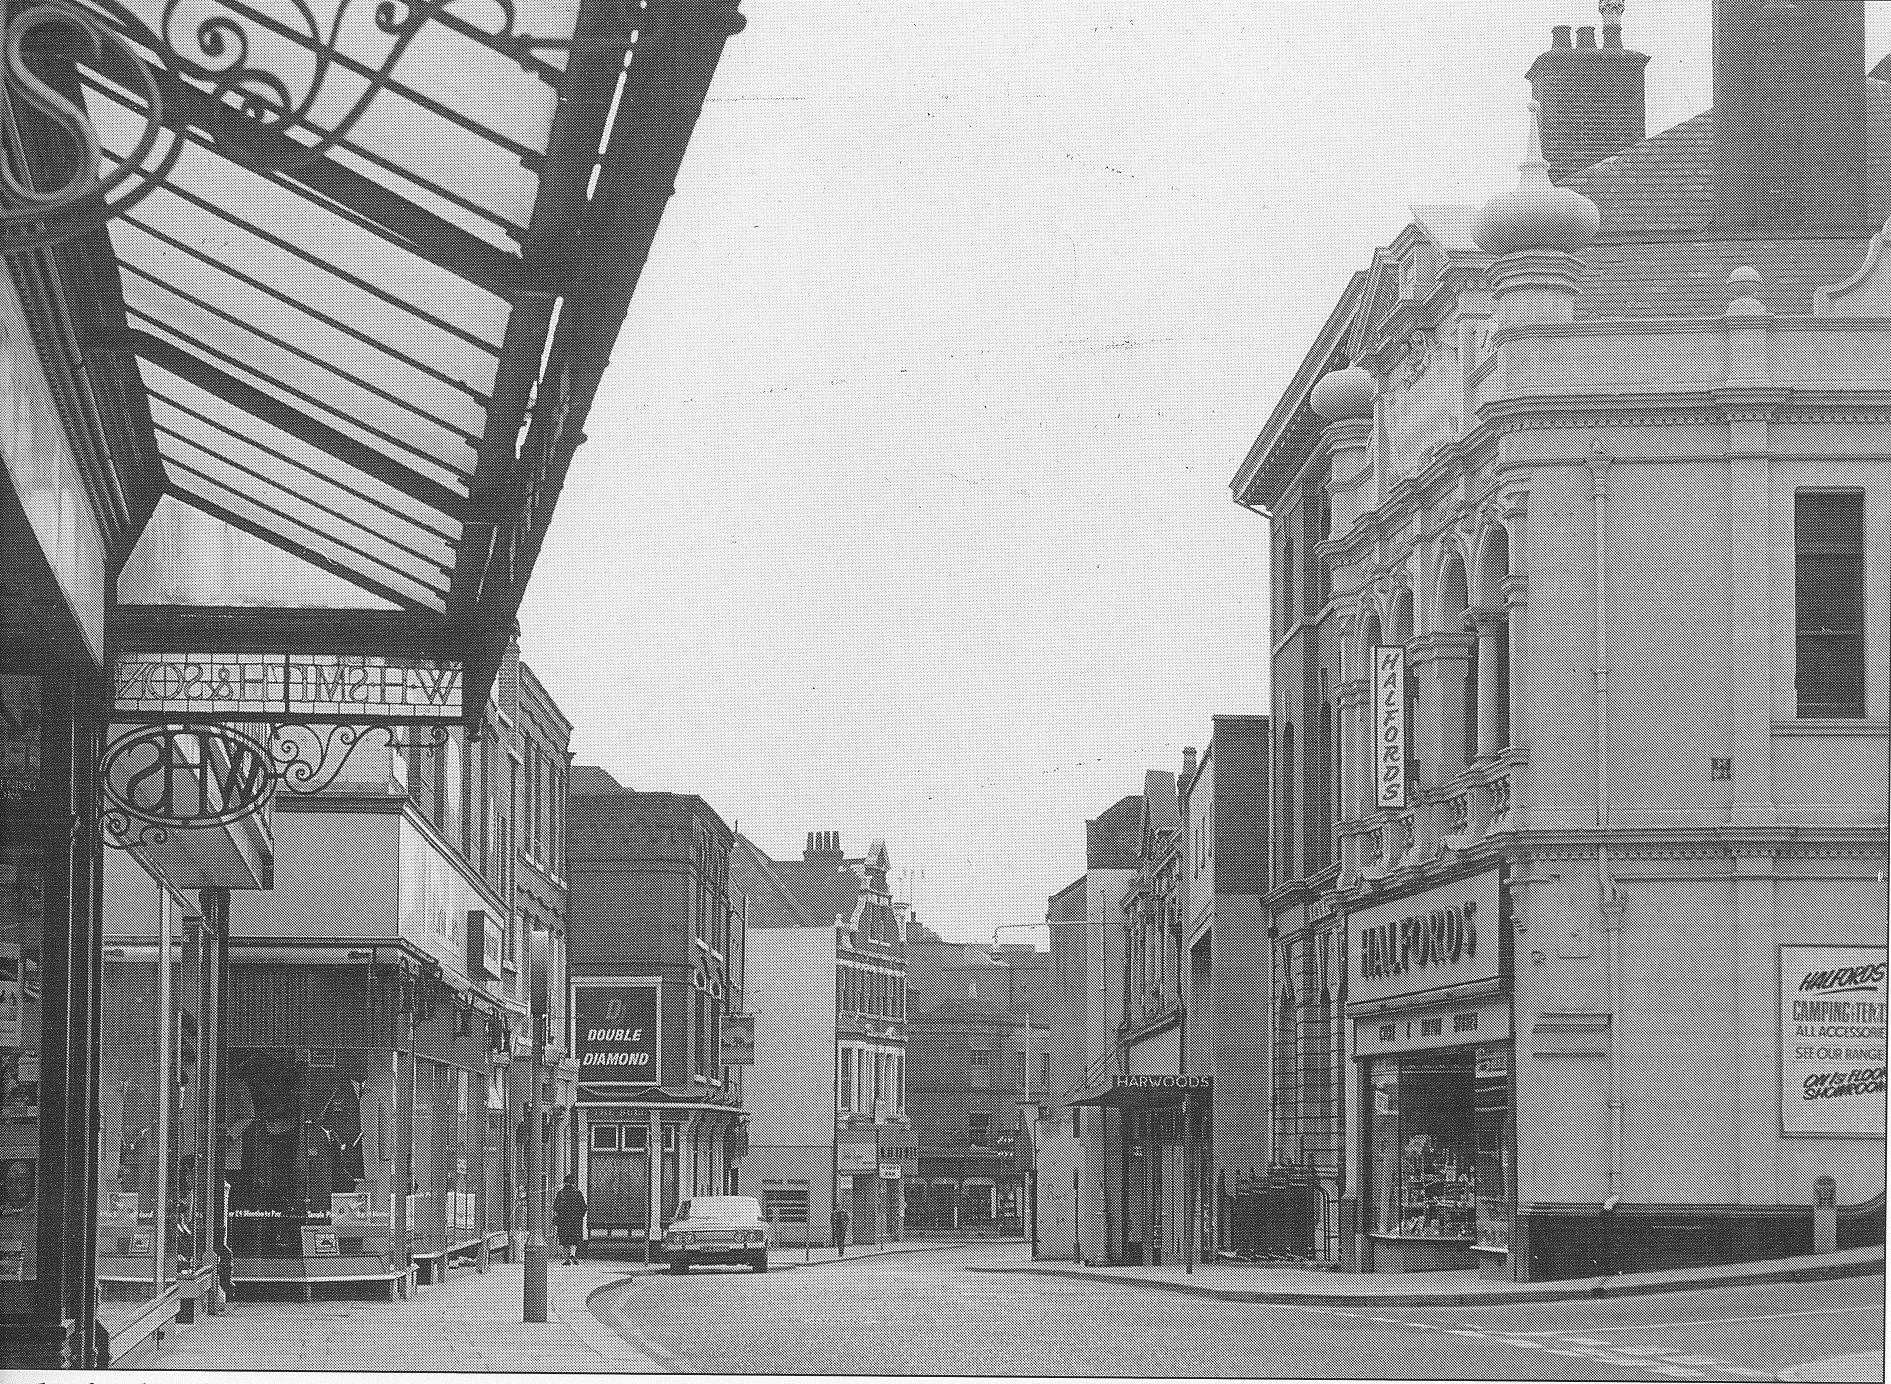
[140,1242,949,1375]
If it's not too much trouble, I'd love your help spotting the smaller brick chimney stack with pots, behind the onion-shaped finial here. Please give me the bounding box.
[1524,0,1649,183]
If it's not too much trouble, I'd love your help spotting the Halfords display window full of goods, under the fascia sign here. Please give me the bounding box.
[1367,1046,1513,1248]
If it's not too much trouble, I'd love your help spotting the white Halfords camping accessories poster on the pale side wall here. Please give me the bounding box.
[1779,947,1891,1138]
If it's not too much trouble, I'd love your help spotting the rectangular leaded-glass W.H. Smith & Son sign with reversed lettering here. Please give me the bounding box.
[112,652,463,722]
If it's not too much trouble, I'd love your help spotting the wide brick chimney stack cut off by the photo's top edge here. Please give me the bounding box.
[1713,0,1872,236]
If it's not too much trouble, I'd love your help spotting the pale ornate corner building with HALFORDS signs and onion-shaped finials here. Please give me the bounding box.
[1233,0,1891,1280]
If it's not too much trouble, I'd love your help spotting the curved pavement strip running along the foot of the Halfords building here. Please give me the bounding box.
[968,1244,1885,1308]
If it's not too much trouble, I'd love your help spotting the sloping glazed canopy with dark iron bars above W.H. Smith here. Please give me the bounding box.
[40,0,741,717]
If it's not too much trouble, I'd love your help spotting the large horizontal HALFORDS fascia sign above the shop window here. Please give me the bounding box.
[1346,870,1498,1004]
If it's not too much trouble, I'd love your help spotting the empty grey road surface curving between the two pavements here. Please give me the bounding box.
[592,1244,1883,1380]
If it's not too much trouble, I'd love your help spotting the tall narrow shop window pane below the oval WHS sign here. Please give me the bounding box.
[98,881,174,1329]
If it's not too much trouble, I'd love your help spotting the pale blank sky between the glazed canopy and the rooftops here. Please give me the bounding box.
[522,0,1891,942]
